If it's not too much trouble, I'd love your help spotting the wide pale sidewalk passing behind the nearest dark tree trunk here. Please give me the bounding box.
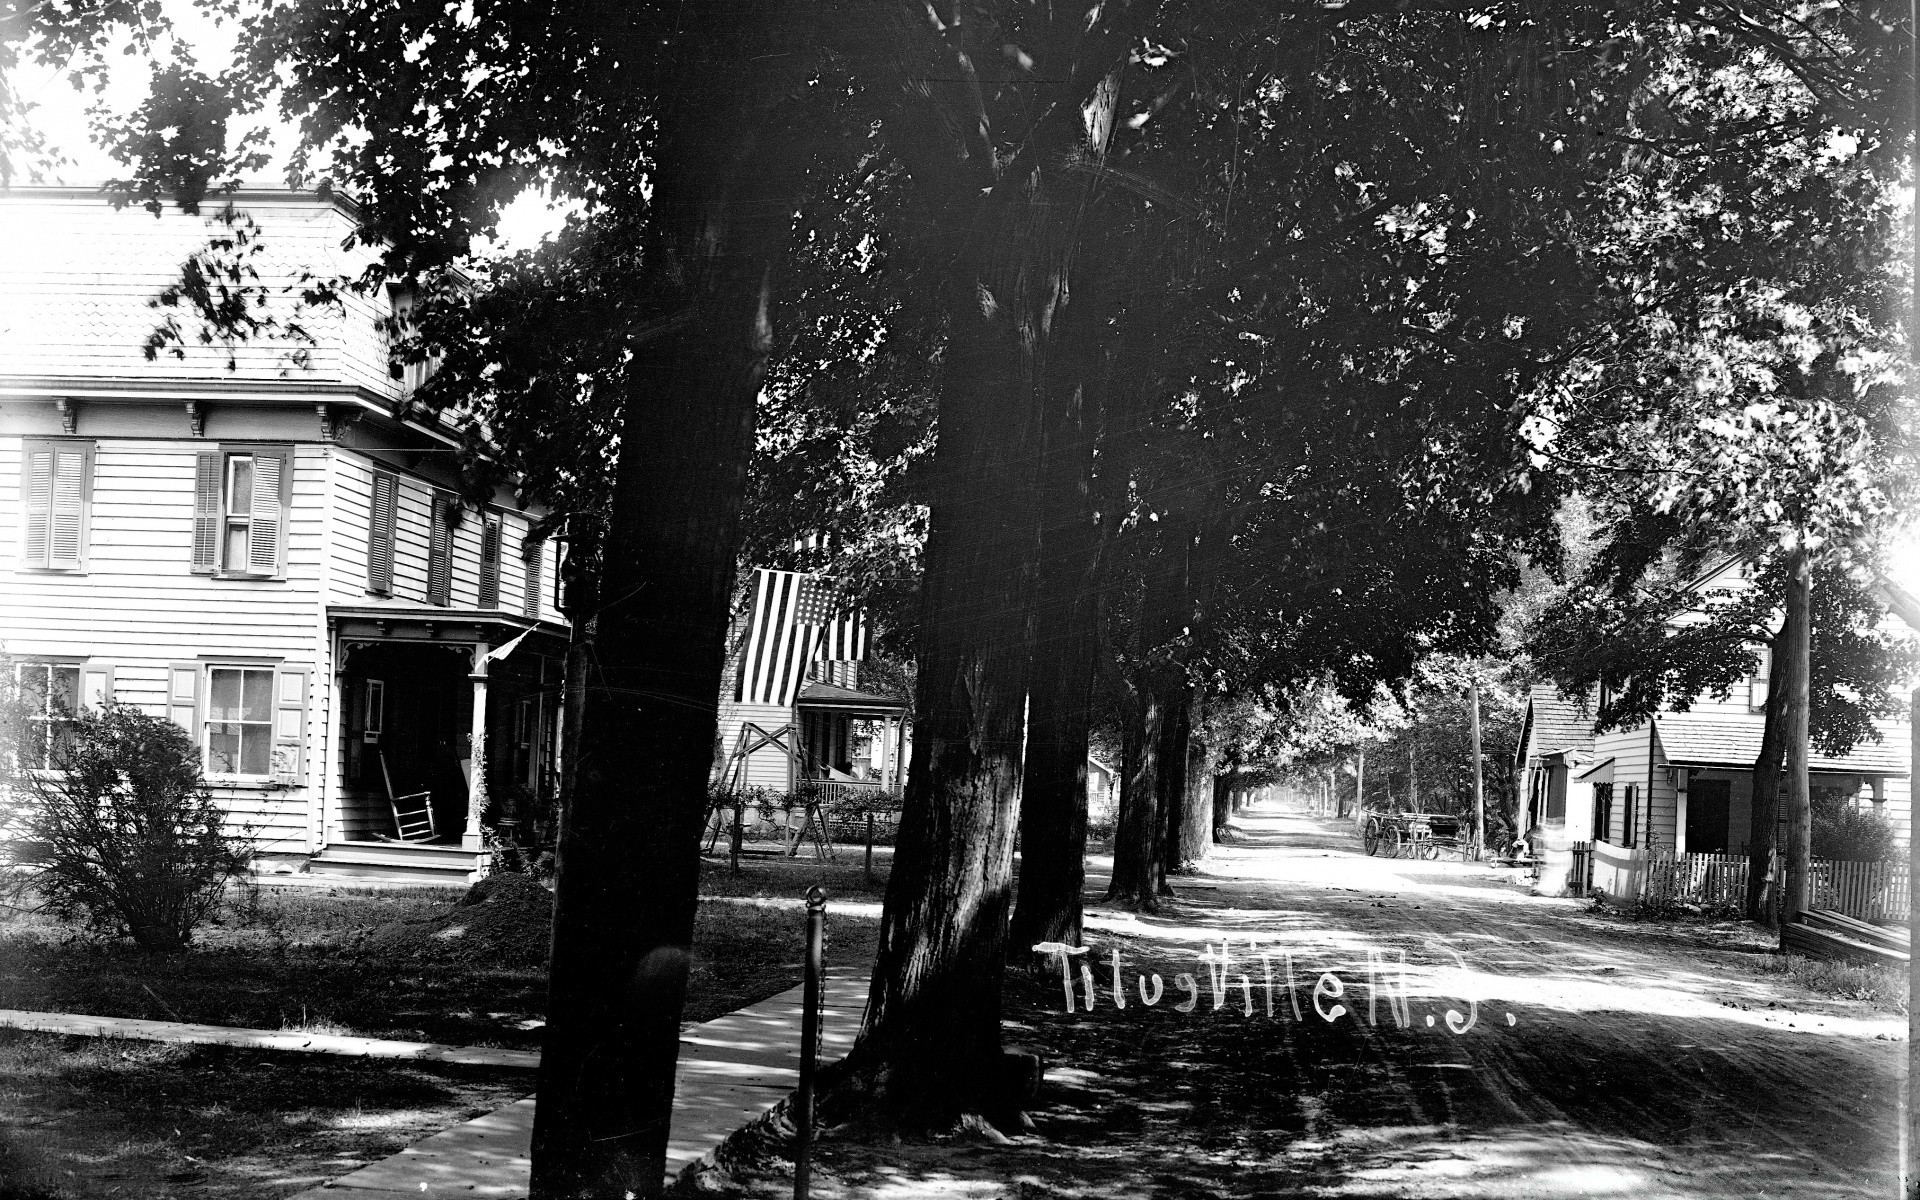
[290,968,868,1200]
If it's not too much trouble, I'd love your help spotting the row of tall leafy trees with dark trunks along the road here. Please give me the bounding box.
[0,0,1903,1198]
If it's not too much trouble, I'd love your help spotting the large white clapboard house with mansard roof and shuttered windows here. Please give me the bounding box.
[0,188,564,877]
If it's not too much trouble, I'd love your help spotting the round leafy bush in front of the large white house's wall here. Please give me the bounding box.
[10,703,253,952]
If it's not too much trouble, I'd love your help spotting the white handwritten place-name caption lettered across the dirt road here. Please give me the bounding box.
[1033,939,1519,1035]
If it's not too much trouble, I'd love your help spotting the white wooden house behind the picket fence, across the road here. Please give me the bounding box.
[1519,563,1910,897]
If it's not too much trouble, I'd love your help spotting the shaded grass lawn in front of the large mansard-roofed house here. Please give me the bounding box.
[0,849,887,1200]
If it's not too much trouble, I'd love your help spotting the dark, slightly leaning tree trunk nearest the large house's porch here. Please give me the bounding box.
[532,61,793,1200]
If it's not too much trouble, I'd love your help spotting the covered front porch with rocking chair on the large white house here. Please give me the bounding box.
[311,609,564,881]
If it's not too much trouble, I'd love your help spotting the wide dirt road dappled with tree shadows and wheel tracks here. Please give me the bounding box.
[768,798,1905,1200]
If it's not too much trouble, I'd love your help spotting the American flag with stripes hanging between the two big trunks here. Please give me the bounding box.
[733,566,866,708]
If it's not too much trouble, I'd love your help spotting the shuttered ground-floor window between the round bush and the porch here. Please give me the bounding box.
[167,662,307,785]
